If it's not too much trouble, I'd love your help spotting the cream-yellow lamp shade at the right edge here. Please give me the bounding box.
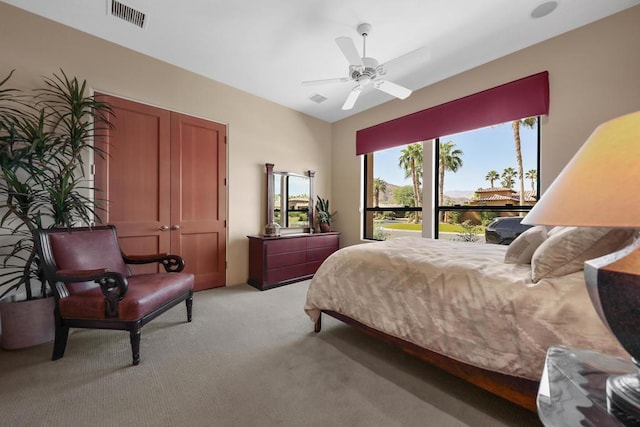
[523,111,640,228]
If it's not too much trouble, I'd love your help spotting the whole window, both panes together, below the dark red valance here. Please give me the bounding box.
[363,117,540,243]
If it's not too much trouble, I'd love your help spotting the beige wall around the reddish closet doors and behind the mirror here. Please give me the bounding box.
[0,3,331,285]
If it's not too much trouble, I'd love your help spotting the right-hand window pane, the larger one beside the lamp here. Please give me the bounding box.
[434,117,540,244]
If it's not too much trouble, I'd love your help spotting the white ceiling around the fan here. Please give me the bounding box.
[3,0,640,122]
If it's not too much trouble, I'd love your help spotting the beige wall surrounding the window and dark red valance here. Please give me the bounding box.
[331,6,640,245]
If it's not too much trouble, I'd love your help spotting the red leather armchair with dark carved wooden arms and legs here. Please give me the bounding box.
[34,225,194,365]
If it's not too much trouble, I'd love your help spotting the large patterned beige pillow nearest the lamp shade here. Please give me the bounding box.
[531,227,635,283]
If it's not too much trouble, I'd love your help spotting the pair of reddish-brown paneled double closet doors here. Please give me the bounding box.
[95,95,226,290]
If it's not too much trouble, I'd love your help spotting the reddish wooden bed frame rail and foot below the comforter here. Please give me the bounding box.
[314,310,540,412]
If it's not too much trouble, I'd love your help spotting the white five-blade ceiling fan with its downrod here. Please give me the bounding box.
[302,23,412,110]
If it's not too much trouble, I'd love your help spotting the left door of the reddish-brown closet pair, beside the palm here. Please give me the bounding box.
[95,94,171,273]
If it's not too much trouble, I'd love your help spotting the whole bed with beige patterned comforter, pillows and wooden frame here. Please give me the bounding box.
[305,227,632,411]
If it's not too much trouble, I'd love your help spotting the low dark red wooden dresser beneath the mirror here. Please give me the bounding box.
[247,232,340,291]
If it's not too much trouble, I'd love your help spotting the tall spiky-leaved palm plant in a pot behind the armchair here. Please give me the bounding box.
[0,70,109,349]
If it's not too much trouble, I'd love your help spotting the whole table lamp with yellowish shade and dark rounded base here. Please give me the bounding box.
[523,111,640,422]
